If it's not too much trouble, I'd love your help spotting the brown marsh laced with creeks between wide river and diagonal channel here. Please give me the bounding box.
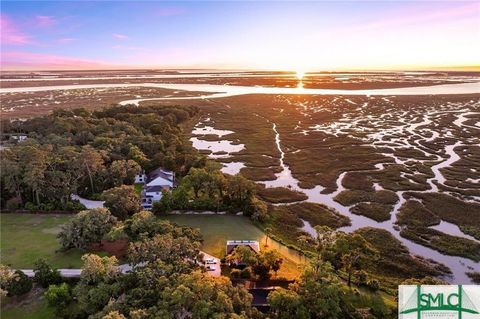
[188,87,480,280]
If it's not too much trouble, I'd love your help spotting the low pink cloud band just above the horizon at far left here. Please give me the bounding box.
[1,51,108,70]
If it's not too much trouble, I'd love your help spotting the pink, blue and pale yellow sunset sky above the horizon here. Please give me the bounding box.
[1,1,480,71]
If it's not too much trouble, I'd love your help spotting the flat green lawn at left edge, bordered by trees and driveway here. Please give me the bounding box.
[0,214,84,270]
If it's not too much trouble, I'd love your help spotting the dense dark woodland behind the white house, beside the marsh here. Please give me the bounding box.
[0,105,202,210]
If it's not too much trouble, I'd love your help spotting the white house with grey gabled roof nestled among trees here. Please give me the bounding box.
[140,167,175,209]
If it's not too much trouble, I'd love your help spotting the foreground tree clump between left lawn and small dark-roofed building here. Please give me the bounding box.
[45,209,260,319]
